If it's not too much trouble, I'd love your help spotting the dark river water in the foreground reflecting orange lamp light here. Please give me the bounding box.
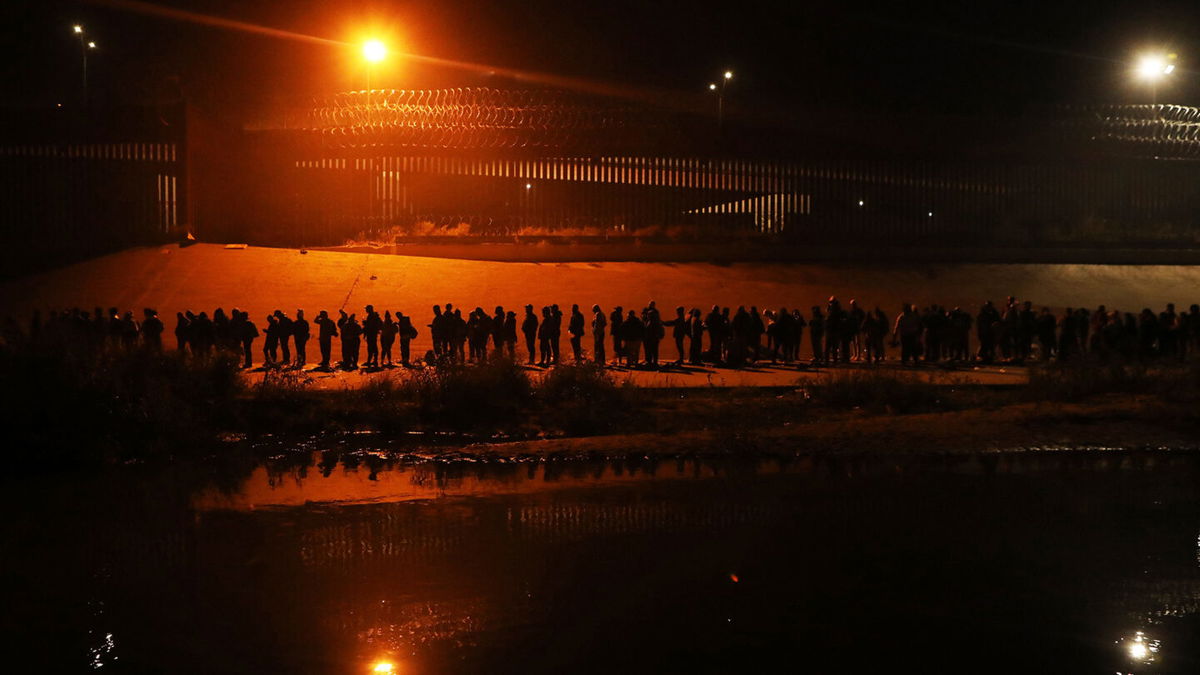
[0,444,1200,674]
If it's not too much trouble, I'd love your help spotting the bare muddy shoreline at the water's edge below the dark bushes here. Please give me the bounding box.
[238,395,1200,462]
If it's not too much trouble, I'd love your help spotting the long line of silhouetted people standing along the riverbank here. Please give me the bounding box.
[7,297,1200,371]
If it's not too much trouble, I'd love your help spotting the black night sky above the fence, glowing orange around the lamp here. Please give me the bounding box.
[7,0,1200,115]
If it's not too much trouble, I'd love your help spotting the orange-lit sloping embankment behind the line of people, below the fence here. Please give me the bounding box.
[7,244,1200,384]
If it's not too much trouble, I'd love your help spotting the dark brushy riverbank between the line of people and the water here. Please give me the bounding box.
[0,336,1200,462]
